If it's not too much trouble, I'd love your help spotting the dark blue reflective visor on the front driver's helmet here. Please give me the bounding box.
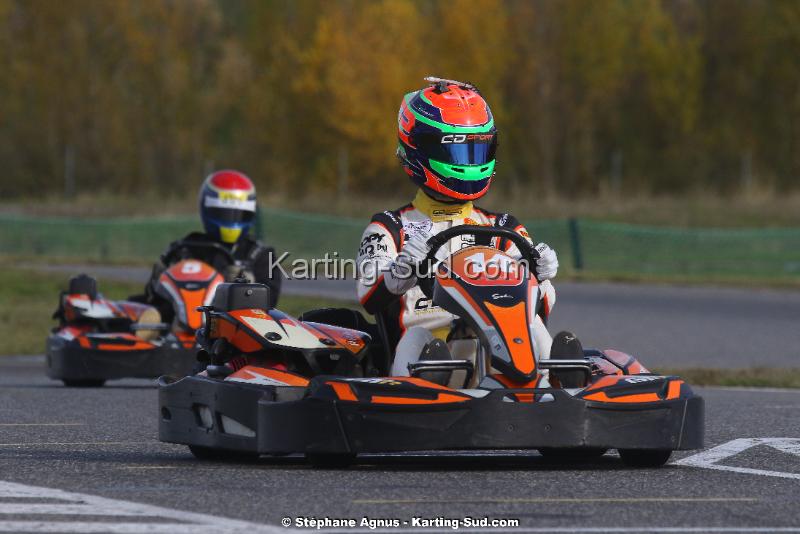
[413,132,497,165]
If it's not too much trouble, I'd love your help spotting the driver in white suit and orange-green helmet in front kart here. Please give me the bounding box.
[357,78,558,382]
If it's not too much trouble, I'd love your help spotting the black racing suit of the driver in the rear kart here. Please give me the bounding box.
[129,232,283,323]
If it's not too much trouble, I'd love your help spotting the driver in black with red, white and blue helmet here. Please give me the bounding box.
[137,170,282,322]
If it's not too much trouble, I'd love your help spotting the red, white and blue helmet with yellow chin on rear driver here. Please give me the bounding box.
[199,170,256,244]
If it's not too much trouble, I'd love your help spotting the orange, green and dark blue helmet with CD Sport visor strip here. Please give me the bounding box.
[397,78,497,202]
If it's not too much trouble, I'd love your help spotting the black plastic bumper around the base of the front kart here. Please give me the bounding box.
[159,376,704,454]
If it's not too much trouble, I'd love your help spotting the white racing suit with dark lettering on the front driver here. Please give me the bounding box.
[356,190,555,368]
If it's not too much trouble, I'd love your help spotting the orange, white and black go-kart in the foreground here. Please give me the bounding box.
[159,226,704,466]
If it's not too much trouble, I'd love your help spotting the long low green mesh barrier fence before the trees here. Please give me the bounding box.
[0,210,800,281]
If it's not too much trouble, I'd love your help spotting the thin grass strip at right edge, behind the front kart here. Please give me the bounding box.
[654,367,800,388]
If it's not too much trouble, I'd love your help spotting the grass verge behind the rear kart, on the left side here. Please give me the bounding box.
[0,266,348,355]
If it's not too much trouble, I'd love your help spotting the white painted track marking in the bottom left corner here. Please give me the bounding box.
[0,481,286,534]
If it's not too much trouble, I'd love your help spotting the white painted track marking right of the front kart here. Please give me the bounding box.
[675,438,800,480]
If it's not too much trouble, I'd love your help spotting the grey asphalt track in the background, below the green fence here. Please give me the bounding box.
[32,265,800,368]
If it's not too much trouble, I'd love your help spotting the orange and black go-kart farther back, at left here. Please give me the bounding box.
[46,243,233,387]
